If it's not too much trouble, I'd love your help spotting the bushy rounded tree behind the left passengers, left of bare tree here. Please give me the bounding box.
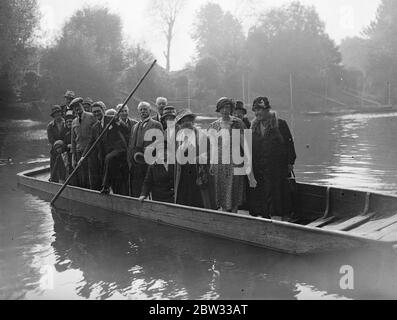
[41,7,124,104]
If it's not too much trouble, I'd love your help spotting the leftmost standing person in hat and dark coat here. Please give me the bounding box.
[47,105,67,182]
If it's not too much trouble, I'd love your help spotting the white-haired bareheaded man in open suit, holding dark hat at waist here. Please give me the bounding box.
[127,102,163,198]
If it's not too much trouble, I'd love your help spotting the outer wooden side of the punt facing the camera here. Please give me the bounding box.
[18,167,396,254]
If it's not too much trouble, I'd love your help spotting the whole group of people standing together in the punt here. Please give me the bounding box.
[47,91,296,218]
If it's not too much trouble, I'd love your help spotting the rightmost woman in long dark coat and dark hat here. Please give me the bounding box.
[248,98,296,218]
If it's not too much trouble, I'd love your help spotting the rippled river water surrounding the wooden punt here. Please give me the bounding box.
[0,114,397,299]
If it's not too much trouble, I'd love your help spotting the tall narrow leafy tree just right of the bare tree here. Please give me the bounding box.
[192,3,246,101]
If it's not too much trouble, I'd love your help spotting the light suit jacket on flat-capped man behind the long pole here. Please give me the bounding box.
[72,112,97,154]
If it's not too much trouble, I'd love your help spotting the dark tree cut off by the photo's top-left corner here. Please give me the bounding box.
[0,0,39,99]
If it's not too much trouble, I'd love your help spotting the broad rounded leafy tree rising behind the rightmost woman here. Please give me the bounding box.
[247,2,341,106]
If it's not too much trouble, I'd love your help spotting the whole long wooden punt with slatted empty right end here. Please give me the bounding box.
[18,167,397,254]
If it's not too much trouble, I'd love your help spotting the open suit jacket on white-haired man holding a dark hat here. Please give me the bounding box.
[127,118,163,169]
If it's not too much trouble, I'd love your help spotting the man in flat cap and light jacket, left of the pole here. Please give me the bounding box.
[70,98,97,189]
